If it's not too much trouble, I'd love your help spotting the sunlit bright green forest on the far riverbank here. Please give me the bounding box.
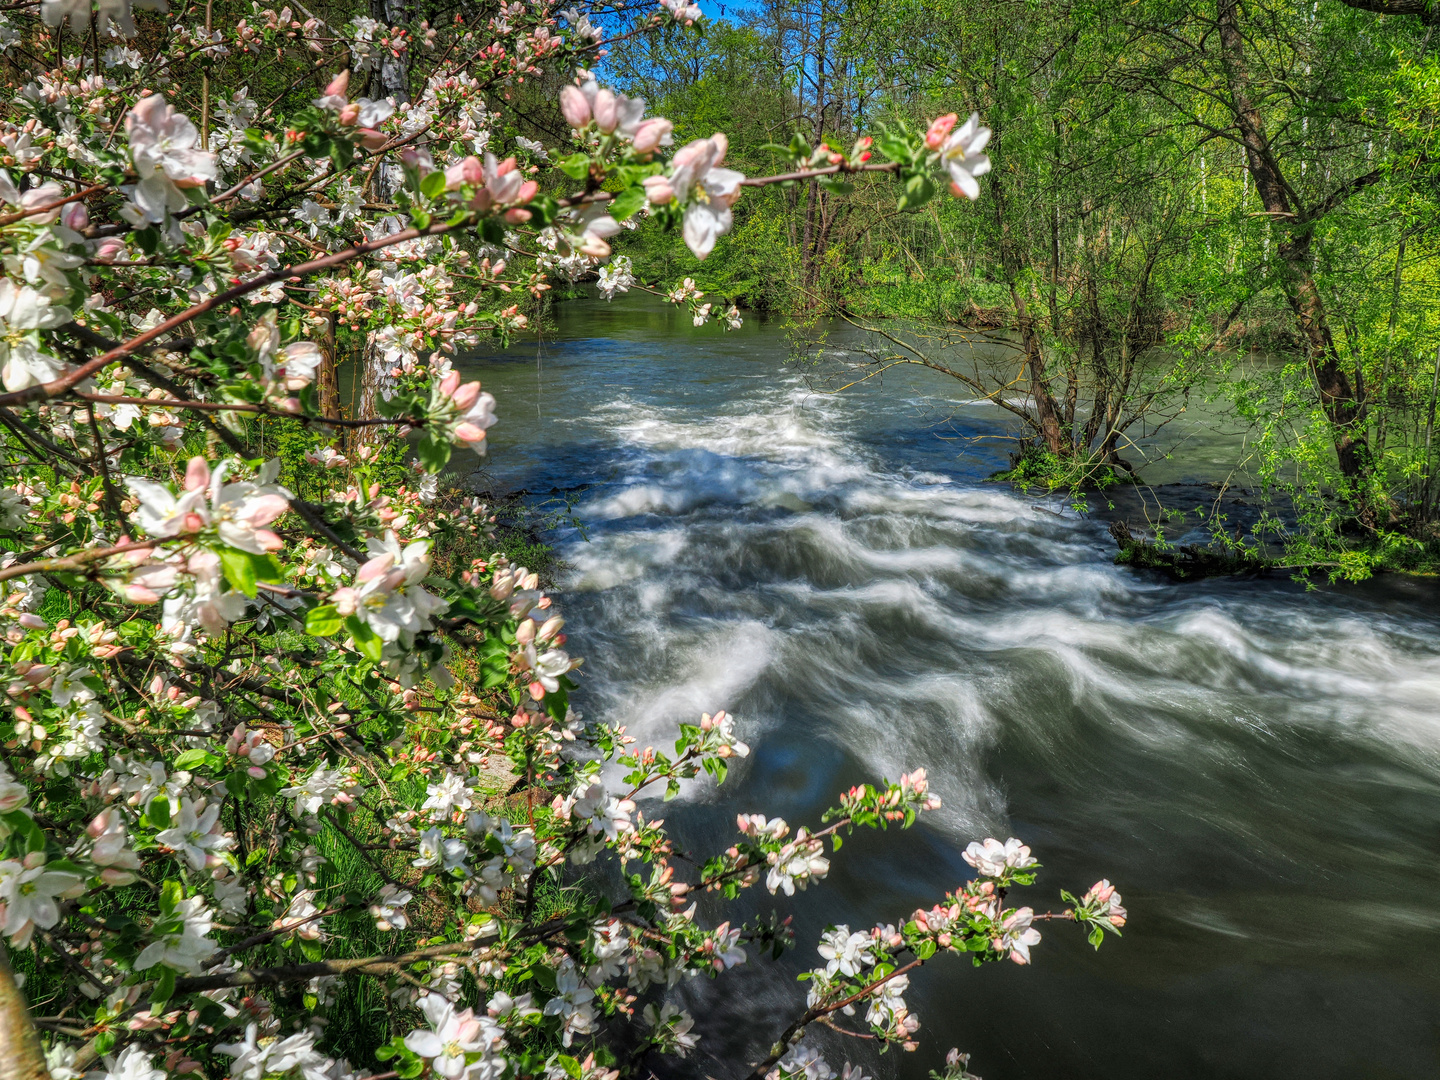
[584,0,1440,576]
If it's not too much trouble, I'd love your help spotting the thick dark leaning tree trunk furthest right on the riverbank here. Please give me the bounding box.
[1217,0,1369,481]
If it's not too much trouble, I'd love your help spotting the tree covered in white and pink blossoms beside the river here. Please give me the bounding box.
[0,0,1125,1080]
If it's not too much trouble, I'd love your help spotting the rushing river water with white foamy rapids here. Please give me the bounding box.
[461,298,1440,1080]
